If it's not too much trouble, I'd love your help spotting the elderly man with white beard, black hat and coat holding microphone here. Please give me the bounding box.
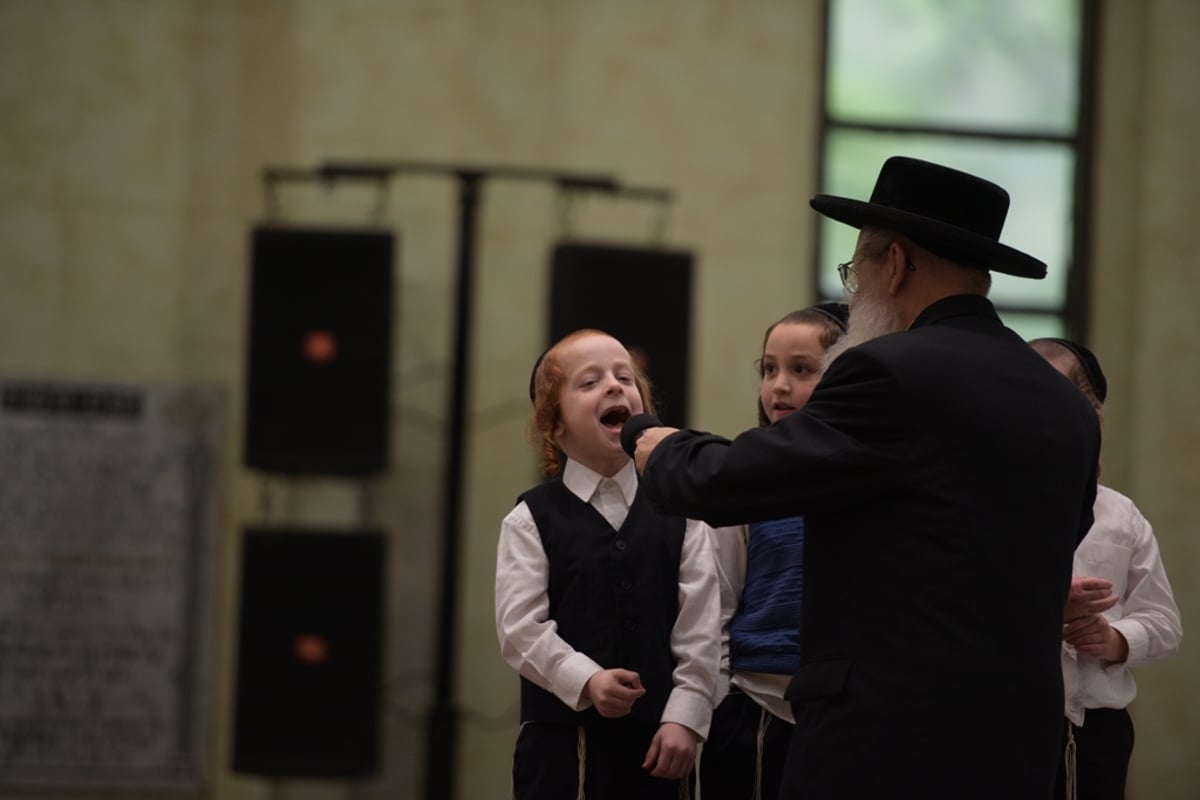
[623,157,1099,800]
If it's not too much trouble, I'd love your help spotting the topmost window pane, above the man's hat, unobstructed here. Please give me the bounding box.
[828,0,1081,136]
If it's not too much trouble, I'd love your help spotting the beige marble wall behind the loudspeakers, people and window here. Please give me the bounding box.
[0,0,1200,800]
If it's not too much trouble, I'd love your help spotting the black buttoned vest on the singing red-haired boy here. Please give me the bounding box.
[520,479,686,727]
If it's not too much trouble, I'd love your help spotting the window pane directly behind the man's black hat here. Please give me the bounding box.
[817,128,1074,312]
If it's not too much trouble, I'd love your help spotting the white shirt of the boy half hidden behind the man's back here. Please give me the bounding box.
[1062,486,1183,724]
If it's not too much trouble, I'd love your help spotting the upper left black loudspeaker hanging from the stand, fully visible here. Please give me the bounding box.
[245,227,395,475]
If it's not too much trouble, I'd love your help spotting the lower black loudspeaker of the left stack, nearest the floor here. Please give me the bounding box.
[233,528,385,777]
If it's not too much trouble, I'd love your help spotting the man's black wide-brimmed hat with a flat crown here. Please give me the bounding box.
[809,156,1046,278]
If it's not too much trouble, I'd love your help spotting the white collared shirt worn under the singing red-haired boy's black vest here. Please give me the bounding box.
[496,459,720,738]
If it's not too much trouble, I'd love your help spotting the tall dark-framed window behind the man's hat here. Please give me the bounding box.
[816,0,1098,339]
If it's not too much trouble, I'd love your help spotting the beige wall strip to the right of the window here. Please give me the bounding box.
[1092,0,1200,799]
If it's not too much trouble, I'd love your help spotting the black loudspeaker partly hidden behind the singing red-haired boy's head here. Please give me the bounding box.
[550,242,692,428]
